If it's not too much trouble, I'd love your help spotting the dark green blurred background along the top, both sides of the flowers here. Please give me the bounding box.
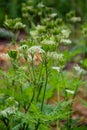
[0,0,87,26]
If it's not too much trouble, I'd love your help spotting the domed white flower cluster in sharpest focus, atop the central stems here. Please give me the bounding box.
[28,46,45,55]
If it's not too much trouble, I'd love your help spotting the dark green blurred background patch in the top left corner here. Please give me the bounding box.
[0,0,26,25]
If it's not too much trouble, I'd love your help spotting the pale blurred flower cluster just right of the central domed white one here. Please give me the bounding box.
[47,52,64,61]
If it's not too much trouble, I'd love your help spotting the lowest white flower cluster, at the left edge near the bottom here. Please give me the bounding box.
[1,106,17,117]
